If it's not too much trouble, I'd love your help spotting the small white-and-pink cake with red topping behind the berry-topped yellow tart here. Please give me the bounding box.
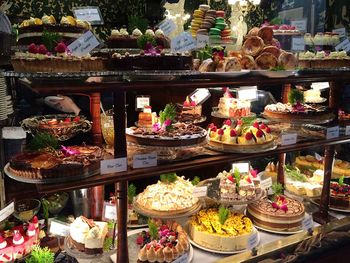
[218,89,251,118]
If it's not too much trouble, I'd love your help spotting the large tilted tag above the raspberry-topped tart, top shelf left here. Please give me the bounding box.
[68,31,100,57]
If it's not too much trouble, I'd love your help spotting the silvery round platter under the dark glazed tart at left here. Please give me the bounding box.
[4,163,100,184]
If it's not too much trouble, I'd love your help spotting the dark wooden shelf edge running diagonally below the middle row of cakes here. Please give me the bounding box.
[37,136,350,194]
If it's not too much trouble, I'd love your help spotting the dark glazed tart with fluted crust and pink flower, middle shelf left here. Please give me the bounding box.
[8,146,103,180]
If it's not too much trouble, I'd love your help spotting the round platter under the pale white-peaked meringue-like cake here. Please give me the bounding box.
[134,201,202,219]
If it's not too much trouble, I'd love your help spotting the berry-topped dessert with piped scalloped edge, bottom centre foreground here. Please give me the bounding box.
[136,221,190,263]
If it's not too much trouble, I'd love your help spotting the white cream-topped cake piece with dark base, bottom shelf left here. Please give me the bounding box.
[70,216,108,254]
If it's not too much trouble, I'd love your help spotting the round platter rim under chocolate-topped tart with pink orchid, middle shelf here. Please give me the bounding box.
[126,127,207,147]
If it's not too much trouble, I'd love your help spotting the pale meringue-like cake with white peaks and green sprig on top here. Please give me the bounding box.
[135,175,198,211]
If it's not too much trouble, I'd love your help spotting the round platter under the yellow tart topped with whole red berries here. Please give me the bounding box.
[207,140,277,153]
